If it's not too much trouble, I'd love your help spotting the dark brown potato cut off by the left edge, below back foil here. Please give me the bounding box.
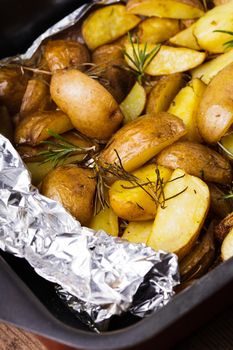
[0,67,28,114]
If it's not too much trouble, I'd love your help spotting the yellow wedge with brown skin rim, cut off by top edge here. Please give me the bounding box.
[127,0,204,19]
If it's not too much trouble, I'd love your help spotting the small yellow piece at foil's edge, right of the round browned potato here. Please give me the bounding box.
[89,208,119,237]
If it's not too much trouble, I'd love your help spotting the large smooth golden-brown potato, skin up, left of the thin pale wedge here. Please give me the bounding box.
[50,69,123,140]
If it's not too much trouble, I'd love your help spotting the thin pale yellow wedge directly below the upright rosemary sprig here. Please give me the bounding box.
[120,82,146,124]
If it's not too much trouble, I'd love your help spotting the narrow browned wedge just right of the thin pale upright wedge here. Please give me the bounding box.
[146,73,184,113]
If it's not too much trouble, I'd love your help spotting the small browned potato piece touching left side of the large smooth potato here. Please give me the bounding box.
[20,79,52,117]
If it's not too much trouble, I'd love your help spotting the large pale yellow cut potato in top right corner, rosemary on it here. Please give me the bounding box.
[194,1,233,53]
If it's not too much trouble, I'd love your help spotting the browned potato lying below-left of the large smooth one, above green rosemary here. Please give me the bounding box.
[15,111,73,146]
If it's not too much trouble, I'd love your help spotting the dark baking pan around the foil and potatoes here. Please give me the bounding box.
[0,0,233,350]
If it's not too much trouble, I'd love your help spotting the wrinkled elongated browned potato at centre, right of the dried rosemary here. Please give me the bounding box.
[99,112,186,171]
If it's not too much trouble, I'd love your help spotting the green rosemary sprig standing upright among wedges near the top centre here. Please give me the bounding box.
[123,33,161,85]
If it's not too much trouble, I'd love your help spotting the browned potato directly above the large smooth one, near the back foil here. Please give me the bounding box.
[44,40,90,72]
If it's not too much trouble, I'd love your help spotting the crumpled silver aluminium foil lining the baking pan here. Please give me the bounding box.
[0,0,179,331]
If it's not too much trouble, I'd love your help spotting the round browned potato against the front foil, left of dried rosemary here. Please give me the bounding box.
[40,165,96,225]
